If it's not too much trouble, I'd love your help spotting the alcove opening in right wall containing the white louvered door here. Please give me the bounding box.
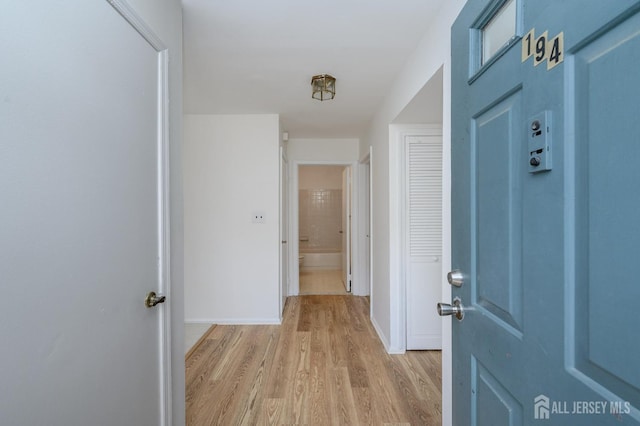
[390,67,447,350]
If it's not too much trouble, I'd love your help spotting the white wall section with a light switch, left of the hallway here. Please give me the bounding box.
[184,114,280,324]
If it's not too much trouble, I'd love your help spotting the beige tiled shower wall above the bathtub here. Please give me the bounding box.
[298,189,342,252]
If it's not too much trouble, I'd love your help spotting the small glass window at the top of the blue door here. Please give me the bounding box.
[480,0,516,66]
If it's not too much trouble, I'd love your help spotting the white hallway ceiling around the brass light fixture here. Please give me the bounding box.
[182,0,445,138]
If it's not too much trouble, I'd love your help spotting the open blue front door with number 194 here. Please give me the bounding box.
[452,0,640,426]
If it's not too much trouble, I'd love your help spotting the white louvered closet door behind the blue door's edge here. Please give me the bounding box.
[404,135,442,349]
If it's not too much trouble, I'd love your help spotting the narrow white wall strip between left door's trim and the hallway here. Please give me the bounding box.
[128,0,185,426]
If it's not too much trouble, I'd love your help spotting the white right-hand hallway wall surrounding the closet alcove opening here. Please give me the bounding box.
[360,0,465,425]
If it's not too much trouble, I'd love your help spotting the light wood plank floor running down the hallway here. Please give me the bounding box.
[186,296,442,425]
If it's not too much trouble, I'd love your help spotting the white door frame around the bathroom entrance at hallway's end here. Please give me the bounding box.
[289,160,363,296]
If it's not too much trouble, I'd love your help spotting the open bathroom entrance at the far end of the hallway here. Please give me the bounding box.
[297,165,352,294]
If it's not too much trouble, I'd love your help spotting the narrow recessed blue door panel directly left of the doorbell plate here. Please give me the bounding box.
[471,90,523,335]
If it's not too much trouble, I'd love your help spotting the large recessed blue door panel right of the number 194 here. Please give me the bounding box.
[571,7,640,401]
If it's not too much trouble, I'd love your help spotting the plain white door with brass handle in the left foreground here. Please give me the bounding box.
[0,0,168,426]
